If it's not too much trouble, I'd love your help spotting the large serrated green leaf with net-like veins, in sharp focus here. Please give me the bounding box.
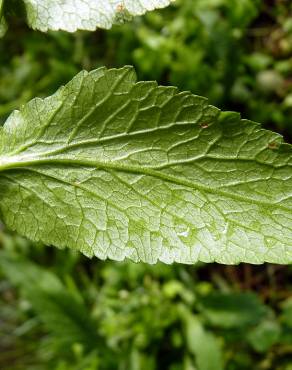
[0,67,292,264]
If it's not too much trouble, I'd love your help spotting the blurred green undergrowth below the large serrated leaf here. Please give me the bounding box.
[0,233,292,370]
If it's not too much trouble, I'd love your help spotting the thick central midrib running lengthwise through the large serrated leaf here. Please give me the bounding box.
[0,152,291,212]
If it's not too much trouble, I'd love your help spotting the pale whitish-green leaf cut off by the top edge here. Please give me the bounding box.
[23,0,173,32]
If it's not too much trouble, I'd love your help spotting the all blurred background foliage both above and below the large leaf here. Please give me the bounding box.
[0,0,292,370]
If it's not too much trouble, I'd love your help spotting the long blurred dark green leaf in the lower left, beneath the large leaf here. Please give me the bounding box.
[0,251,101,351]
